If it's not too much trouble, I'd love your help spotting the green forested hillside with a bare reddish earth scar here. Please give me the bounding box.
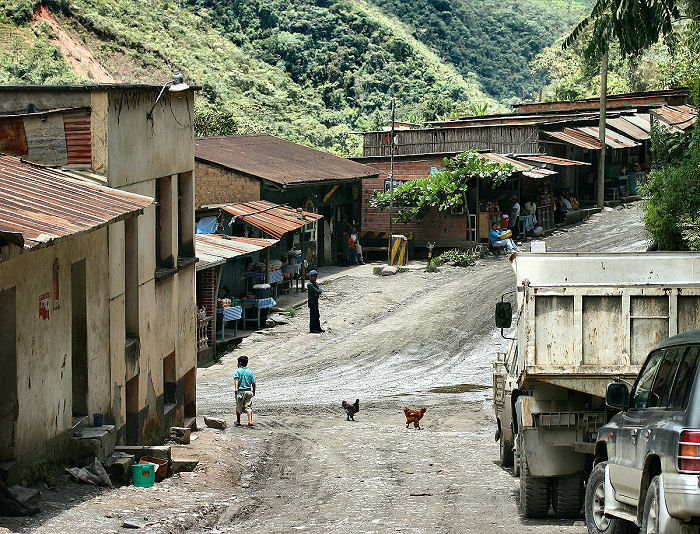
[0,0,590,153]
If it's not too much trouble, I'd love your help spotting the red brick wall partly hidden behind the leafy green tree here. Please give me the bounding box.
[361,156,467,240]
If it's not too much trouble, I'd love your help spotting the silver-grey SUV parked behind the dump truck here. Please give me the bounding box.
[584,330,700,534]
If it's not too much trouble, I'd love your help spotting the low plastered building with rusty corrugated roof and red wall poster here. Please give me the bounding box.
[0,156,153,478]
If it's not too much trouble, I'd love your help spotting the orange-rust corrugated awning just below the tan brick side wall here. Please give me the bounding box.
[220,200,323,239]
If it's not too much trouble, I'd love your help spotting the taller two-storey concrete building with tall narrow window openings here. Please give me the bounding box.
[0,82,197,472]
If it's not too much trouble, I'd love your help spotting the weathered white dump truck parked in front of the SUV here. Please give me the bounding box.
[493,252,700,517]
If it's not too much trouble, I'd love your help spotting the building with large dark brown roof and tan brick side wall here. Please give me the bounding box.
[195,134,378,266]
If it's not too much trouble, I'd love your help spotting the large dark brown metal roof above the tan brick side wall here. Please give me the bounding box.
[194,134,379,186]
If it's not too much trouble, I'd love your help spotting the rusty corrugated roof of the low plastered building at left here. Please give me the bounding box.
[0,155,153,249]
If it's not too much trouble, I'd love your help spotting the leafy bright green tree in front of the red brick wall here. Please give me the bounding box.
[371,150,516,222]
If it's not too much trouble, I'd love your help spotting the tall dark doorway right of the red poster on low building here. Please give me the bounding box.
[70,260,88,417]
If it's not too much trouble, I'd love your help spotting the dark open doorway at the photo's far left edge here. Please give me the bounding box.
[0,288,19,462]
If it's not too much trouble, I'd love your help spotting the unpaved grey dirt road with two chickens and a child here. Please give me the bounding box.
[5,207,646,534]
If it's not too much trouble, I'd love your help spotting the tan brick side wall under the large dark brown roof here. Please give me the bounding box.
[194,161,260,206]
